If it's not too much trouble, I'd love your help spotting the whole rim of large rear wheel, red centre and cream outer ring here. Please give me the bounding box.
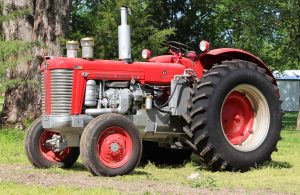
[220,84,270,152]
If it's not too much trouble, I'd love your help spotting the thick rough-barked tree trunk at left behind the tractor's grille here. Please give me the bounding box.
[1,0,71,123]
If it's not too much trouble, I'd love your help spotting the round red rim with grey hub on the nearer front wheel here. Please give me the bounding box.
[97,126,132,168]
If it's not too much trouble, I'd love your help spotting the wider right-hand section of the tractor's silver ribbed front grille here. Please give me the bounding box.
[50,69,73,115]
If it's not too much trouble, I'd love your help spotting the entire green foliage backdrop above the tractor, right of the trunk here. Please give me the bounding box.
[68,0,300,70]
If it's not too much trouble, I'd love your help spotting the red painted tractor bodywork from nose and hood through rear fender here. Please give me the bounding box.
[41,48,276,115]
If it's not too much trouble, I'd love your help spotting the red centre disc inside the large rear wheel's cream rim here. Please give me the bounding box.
[222,91,254,145]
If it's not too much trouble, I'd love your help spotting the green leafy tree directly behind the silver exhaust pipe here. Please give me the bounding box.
[68,0,174,60]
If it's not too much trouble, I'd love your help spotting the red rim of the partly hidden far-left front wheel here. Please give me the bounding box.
[39,130,71,162]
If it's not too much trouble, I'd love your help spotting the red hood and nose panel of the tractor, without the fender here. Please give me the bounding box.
[41,58,186,115]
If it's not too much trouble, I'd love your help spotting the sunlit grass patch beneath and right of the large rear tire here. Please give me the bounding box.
[122,130,300,193]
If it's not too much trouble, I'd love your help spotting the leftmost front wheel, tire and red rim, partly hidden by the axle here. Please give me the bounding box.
[25,118,79,168]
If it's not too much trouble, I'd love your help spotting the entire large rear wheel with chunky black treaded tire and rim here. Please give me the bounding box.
[184,60,282,171]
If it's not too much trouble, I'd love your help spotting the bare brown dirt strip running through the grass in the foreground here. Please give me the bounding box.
[0,165,281,195]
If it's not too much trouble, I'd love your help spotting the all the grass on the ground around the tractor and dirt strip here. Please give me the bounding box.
[0,113,300,194]
